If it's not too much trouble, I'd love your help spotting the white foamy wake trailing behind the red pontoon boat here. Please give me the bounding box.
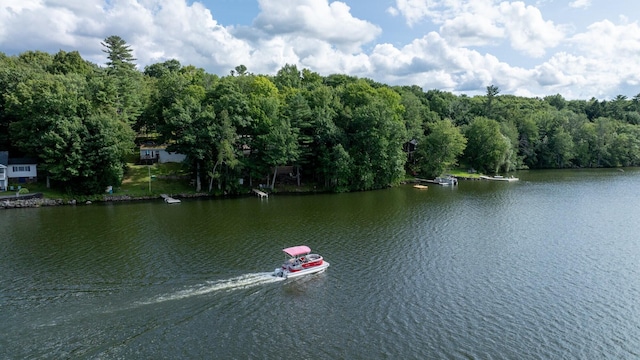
[143,272,285,304]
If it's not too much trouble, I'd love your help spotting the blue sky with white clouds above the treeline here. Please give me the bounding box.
[0,0,640,100]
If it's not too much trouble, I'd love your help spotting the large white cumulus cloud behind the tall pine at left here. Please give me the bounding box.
[0,0,251,71]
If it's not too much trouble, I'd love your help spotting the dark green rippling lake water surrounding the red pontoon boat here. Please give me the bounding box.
[0,169,640,359]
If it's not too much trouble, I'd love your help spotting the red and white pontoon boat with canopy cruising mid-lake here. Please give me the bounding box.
[273,245,329,279]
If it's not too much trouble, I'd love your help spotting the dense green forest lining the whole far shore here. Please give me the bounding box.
[0,36,640,194]
